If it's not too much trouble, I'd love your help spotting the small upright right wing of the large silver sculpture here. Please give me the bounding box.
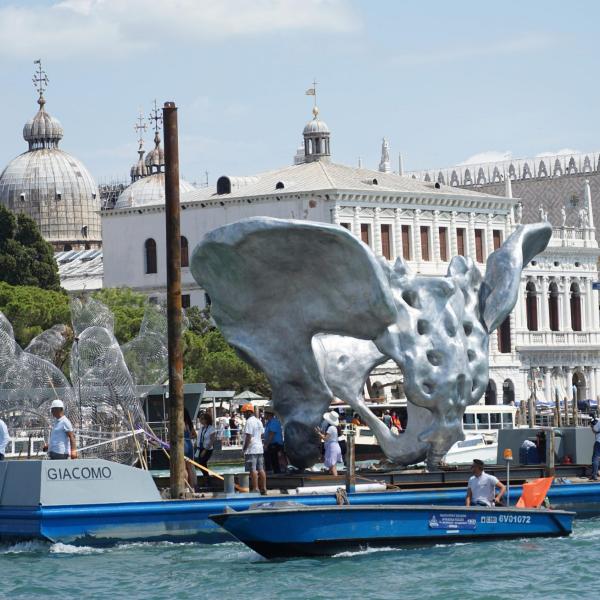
[479,222,552,333]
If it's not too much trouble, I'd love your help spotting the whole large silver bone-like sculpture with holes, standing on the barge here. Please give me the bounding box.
[192,217,552,467]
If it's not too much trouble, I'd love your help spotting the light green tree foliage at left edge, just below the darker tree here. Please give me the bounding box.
[0,282,71,347]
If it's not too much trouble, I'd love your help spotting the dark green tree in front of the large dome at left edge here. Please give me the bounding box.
[0,206,60,291]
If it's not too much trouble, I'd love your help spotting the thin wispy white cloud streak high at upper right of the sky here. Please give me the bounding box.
[392,32,556,67]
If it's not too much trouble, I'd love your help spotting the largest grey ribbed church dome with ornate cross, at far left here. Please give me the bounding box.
[0,61,102,250]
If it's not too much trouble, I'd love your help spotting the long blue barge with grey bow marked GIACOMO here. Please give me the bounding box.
[0,459,600,545]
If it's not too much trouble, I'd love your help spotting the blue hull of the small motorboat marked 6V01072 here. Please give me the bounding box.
[210,505,574,558]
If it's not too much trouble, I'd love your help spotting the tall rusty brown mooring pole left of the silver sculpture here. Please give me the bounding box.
[163,102,185,498]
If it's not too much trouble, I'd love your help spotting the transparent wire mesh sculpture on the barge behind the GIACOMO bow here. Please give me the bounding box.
[0,298,168,463]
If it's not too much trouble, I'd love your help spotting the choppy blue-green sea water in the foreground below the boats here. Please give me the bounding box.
[0,519,600,600]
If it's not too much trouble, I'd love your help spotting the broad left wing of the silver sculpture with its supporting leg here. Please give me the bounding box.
[191,217,396,466]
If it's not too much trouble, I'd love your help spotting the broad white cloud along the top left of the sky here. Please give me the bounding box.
[0,0,361,59]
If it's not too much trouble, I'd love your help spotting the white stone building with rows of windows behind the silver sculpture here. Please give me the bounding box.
[102,110,600,403]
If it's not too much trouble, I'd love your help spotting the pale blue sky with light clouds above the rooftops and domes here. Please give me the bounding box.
[0,0,600,184]
